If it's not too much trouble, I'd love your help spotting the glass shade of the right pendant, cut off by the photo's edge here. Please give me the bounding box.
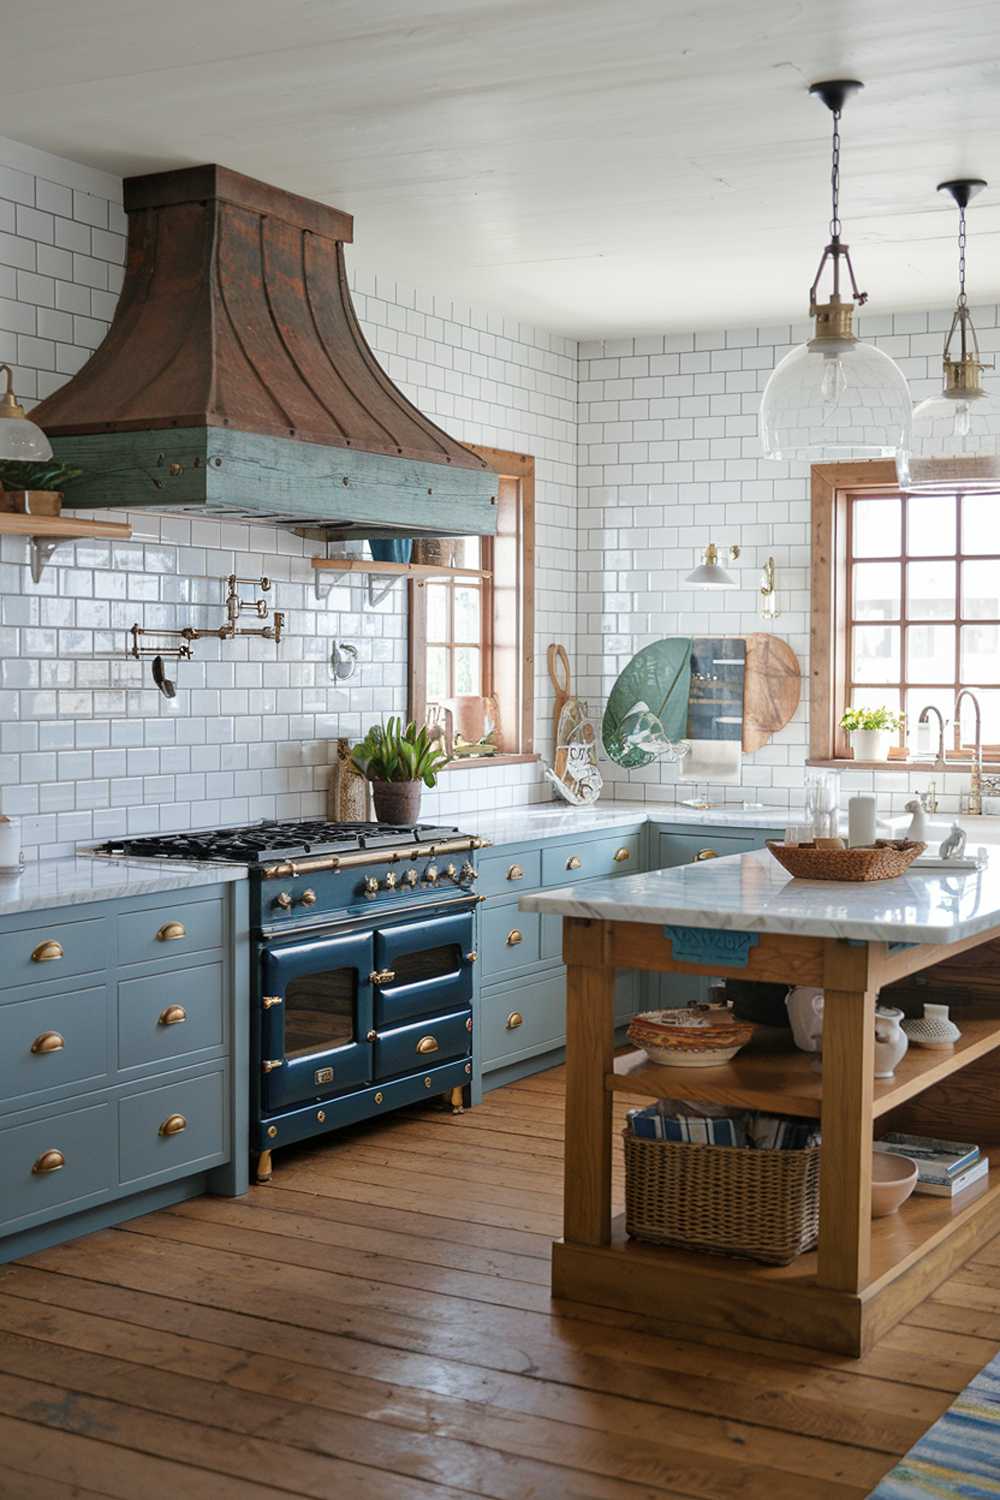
[897,381,1000,494]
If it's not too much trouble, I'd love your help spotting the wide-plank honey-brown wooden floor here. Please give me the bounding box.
[0,1068,1000,1500]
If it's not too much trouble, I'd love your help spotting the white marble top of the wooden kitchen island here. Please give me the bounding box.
[519,849,1000,944]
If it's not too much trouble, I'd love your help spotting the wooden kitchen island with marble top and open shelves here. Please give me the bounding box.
[520,851,1000,1355]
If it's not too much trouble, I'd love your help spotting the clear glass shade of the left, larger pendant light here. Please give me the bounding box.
[760,339,913,464]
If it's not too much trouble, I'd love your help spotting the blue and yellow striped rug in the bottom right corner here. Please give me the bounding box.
[868,1355,1000,1500]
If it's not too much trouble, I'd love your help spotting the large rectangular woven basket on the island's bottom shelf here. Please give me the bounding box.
[622,1130,822,1266]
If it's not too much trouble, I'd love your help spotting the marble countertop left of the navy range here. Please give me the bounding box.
[0,855,246,917]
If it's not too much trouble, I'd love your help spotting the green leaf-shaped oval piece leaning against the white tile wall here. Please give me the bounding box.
[601,636,691,770]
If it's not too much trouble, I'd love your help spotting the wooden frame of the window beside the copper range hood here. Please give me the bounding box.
[408,444,538,771]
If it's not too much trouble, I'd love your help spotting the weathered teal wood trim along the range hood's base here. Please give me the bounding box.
[52,428,496,536]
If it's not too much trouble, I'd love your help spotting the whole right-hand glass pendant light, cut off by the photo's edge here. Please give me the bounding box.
[897,177,1000,495]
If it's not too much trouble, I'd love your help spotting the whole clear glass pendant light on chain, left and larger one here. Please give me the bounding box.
[760,78,912,464]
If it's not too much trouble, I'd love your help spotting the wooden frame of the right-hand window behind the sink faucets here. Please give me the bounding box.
[808,459,996,771]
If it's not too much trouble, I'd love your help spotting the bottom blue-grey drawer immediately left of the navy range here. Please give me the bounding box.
[118,1073,226,1184]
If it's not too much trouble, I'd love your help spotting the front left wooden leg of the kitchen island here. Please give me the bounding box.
[562,930,615,1245]
